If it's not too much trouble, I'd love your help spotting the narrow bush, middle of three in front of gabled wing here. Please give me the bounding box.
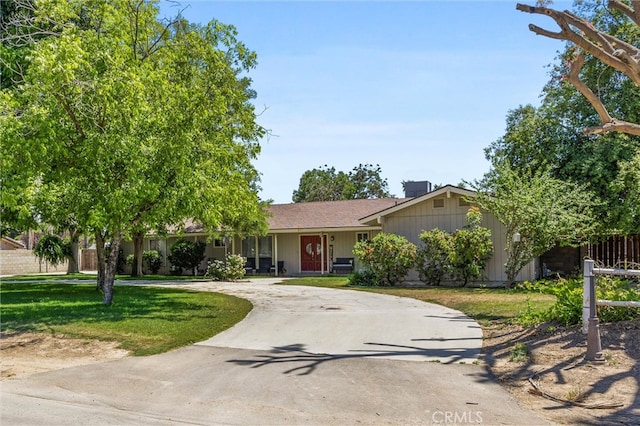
[416,228,453,286]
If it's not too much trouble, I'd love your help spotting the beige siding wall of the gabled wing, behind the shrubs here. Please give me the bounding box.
[383,193,536,282]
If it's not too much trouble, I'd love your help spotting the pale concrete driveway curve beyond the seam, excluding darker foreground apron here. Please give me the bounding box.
[180,279,482,364]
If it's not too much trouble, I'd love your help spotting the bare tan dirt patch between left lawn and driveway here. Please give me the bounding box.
[0,333,129,380]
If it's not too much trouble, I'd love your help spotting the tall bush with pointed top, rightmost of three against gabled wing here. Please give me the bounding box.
[450,207,493,287]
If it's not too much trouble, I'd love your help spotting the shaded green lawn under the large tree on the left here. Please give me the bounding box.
[0,281,252,355]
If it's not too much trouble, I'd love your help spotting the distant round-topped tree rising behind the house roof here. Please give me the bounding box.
[292,164,391,203]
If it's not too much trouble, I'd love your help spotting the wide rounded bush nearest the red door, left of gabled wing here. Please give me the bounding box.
[353,232,416,286]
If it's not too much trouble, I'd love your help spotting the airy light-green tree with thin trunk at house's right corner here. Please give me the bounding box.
[472,164,598,287]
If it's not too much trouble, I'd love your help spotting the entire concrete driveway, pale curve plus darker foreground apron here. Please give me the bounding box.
[0,280,546,425]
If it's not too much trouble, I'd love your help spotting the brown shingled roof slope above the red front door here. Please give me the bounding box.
[267,198,406,232]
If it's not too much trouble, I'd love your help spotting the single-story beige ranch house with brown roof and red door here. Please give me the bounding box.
[123,185,538,283]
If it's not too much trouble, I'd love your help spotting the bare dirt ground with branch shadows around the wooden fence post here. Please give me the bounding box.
[483,321,640,425]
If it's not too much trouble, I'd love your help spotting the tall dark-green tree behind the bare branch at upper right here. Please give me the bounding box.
[485,2,640,236]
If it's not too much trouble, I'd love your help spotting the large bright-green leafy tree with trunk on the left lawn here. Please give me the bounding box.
[0,0,264,305]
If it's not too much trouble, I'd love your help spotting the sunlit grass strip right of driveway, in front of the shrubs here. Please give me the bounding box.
[283,277,556,325]
